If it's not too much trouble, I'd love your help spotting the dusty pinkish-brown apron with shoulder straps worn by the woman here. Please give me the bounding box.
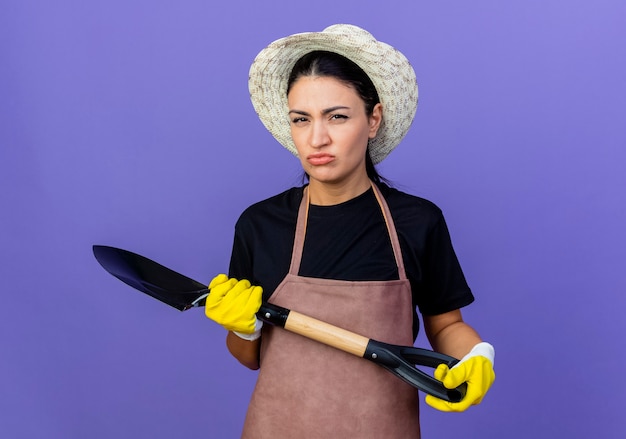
[242,184,420,439]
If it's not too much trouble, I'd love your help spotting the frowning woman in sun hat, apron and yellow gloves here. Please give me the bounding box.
[205,25,495,438]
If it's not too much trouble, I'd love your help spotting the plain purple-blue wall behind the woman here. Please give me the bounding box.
[0,0,626,439]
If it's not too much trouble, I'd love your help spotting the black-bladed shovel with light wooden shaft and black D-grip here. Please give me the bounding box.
[93,245,467,402]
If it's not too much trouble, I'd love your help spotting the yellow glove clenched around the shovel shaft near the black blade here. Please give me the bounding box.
[204,274,263,340]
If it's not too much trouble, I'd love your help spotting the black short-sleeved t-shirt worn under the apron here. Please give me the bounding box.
[229,184,474,334]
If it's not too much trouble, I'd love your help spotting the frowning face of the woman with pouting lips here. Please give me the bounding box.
[287,76,382,184]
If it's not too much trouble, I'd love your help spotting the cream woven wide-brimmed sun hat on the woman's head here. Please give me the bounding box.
[248,24,417,164]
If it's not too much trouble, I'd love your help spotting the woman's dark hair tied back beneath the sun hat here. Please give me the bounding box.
[287,50,386,183]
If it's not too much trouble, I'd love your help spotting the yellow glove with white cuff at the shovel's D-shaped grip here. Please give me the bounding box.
[426,342,496,412]
